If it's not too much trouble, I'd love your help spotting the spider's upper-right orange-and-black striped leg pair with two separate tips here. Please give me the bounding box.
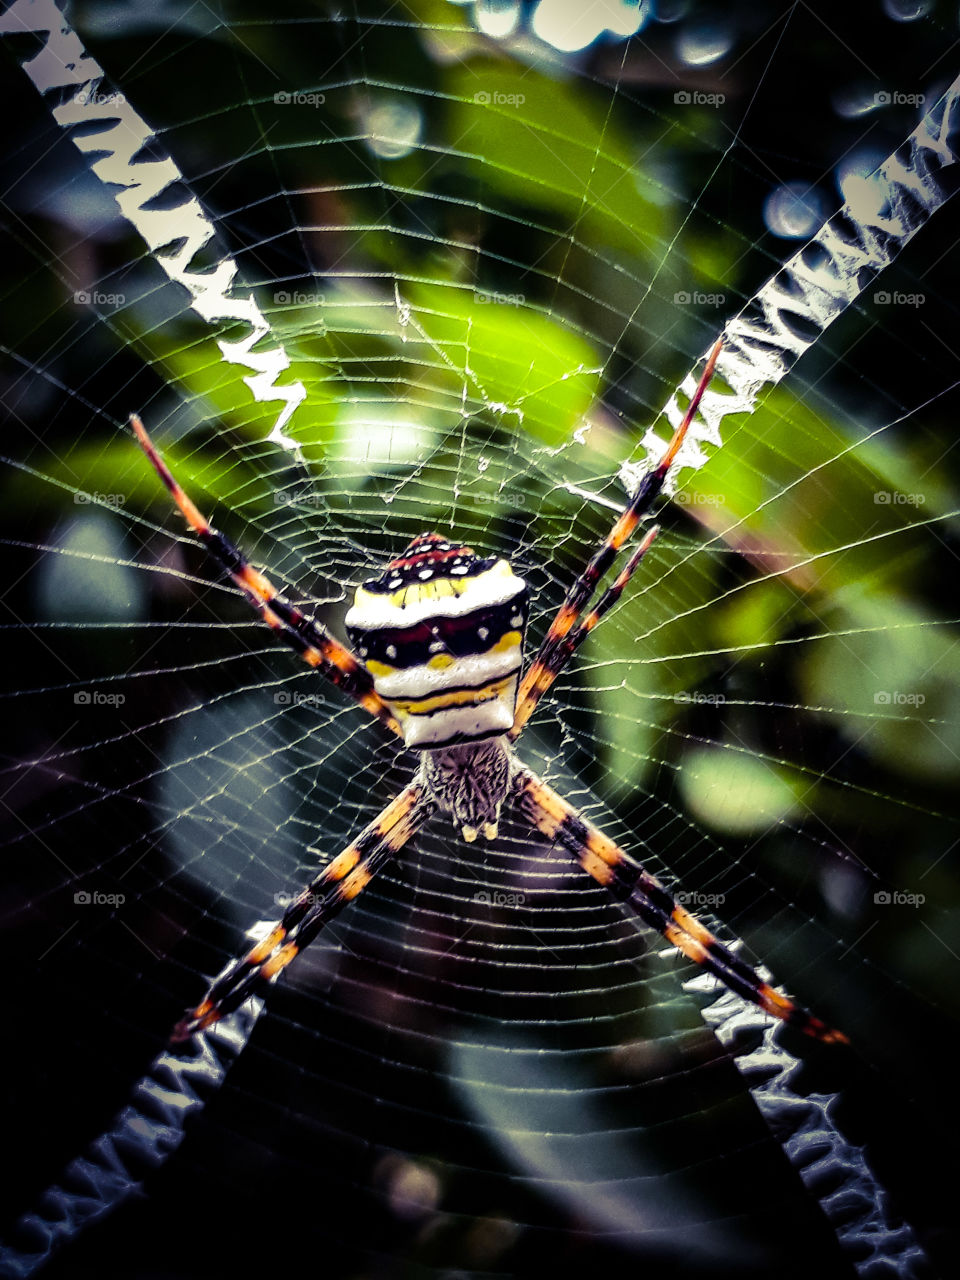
[509,338,723,740]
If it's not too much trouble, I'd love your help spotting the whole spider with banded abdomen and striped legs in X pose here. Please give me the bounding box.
[131,338,847,1043]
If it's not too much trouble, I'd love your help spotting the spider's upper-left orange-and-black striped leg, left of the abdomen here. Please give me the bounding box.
[131,413,401,733]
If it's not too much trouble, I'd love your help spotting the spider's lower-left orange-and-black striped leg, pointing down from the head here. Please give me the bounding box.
[170,782,435,1043]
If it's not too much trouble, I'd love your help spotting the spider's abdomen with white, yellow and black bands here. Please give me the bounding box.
[346,534,529,750]
